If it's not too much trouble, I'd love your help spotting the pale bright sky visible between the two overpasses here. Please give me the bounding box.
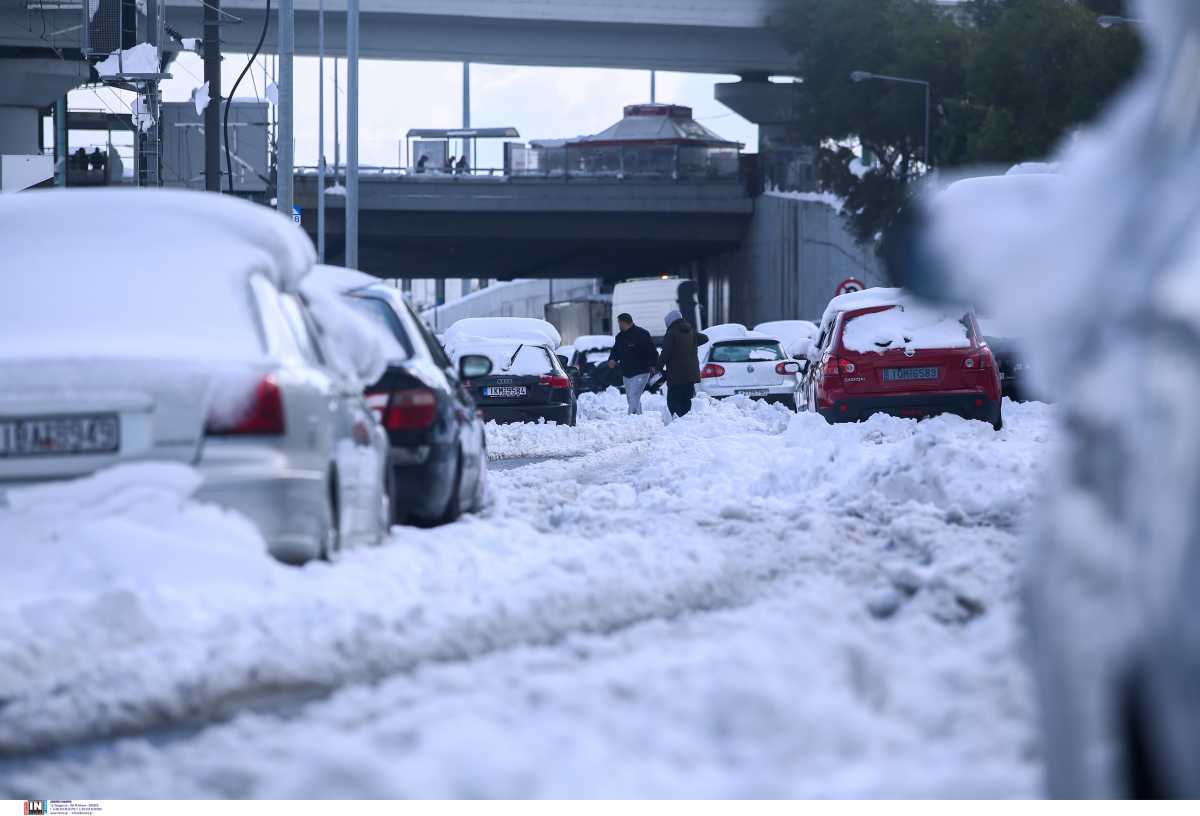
[71,53,758,167]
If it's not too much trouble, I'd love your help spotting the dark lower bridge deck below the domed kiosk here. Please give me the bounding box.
[295,173,754,280]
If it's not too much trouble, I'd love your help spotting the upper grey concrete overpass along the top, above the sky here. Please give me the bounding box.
[167,0,796,74]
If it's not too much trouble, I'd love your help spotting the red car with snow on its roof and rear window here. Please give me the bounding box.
[804,289,1003,431]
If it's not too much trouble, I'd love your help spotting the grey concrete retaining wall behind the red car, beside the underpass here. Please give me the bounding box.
[689,193,886,325]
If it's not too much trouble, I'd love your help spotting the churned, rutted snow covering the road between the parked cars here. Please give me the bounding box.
[0,394,1054,798]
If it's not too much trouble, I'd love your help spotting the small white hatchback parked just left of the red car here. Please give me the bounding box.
[696,323,800,410]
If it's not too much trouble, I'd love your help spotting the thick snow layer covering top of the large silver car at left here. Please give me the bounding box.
[0,190,316,360]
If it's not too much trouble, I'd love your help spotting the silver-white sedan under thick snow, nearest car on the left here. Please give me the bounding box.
[0,190,388,562]
